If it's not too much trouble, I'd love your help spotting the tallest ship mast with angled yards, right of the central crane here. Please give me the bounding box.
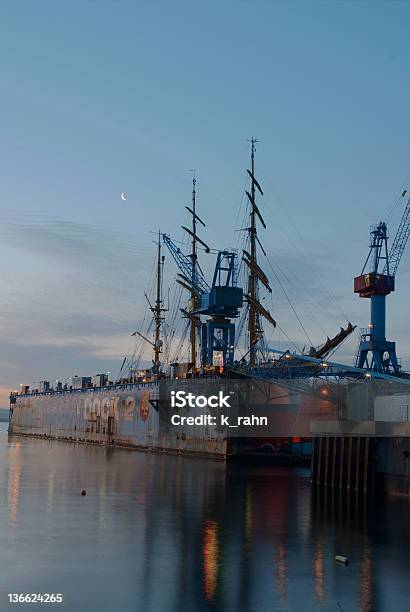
[242,138,276,366]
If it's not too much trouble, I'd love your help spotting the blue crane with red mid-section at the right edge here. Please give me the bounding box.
[354,191,410,374]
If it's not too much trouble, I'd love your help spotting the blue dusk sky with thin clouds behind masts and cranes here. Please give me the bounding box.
[0,0,410,406]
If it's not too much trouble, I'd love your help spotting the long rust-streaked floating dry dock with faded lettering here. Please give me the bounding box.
[9,378,318,459]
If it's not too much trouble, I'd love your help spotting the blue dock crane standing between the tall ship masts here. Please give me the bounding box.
[163,234,243,367]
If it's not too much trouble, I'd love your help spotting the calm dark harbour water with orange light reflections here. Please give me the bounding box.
[0,424,410,612]
